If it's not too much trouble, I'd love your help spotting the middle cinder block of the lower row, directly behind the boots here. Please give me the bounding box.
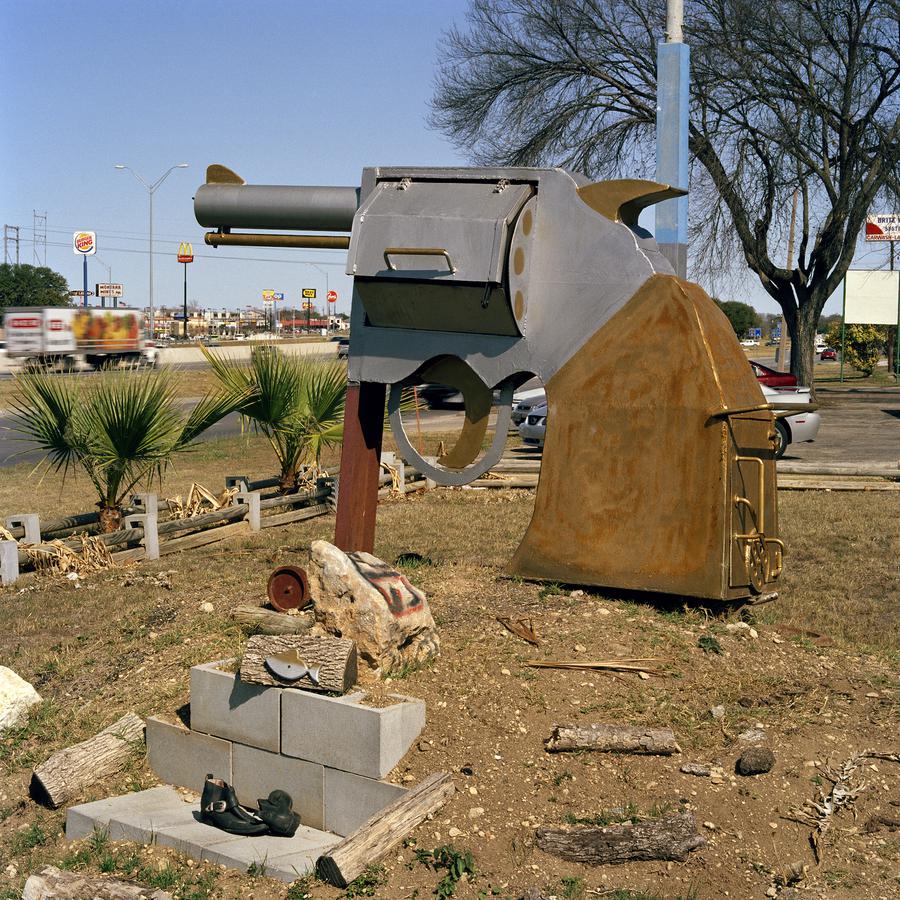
[231,744,325,828]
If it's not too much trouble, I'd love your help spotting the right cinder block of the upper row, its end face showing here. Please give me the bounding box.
[281,688,425,778]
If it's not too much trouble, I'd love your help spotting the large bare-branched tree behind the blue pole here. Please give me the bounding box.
[431,0,900,384]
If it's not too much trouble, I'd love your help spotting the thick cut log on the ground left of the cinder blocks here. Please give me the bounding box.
[31,713,144,809]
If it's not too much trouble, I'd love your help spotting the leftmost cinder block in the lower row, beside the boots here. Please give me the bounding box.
[147,716,231,793]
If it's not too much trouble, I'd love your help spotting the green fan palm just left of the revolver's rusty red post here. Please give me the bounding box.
[202,345,347,492]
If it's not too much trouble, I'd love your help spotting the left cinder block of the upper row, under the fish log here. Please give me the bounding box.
[191,660,281,753]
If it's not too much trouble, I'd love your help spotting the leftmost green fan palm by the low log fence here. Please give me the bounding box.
[12,370,246,532]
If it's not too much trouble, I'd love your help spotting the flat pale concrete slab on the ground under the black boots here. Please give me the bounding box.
[66,787,341,882]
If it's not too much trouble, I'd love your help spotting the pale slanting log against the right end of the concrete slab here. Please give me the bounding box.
[316,772,456,888]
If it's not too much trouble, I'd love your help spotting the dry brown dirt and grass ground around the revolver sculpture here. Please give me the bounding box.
[0,490,900,900]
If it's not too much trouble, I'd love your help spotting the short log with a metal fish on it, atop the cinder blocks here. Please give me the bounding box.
[240,632,357,694]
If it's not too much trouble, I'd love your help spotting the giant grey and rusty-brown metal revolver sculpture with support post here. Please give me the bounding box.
[195,166,783,600]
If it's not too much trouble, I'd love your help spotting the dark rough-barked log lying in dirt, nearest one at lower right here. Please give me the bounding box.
[535,812,706,866]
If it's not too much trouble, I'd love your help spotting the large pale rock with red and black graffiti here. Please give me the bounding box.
[307,541,440,675]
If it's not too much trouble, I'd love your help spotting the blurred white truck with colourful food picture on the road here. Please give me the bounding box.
[4,306,158,370]
